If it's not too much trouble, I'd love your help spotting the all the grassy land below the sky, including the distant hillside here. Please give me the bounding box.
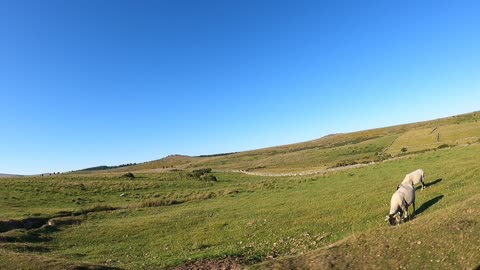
[0,110,480,269]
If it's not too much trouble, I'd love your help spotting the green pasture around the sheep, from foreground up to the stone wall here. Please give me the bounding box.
[0,144,480,269]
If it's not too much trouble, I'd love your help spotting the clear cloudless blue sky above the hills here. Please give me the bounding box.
[0,0,480,174]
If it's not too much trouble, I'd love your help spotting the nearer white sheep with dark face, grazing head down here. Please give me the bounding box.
[385,184,415,225]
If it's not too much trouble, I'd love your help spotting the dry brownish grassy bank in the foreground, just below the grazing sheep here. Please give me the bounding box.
[251,195,480,269]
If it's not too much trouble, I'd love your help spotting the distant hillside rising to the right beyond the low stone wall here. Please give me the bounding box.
[75,112,480,174]
